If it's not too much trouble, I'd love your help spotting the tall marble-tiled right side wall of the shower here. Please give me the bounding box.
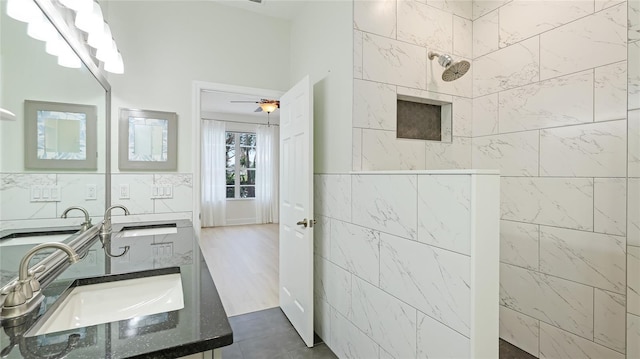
[471,0,640,358]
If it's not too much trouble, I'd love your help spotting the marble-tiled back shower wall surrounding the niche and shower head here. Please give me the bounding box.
[352,0,474,171]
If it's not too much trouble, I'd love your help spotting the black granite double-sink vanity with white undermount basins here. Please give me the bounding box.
[0,220,233,358]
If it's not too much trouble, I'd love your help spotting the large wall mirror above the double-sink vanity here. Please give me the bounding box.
[0,1,109,286]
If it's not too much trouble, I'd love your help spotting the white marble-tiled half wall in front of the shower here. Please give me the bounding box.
[314,173,500,359]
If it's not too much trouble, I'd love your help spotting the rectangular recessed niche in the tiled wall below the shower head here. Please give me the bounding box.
[396,95,452,142]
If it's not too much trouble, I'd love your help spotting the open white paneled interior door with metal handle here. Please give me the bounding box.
[279,76,314,347]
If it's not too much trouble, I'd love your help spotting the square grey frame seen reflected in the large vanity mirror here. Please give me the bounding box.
[24,100,98,170]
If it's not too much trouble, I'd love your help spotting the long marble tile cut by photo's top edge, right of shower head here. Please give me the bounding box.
[499,0,593,47]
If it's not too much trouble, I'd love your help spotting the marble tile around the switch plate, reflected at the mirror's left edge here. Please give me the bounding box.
[0,173,57,221]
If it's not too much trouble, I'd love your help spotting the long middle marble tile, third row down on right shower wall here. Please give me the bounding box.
[498,70,593,133]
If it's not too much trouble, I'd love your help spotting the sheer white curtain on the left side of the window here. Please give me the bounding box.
[201,120,227,227]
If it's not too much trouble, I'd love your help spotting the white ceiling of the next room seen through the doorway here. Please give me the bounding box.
[200,91,280,123]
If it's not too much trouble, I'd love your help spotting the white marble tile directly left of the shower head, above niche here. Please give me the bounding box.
[362,33,427,89]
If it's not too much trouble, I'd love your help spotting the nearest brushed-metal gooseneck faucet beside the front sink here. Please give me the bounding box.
[1,242,80,318]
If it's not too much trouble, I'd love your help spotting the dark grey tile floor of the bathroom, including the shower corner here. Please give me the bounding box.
[222,308,535,359]
